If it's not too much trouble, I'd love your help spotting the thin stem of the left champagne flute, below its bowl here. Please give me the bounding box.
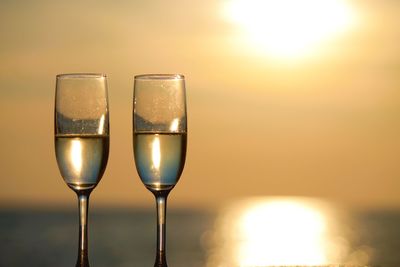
[76,191,90,267]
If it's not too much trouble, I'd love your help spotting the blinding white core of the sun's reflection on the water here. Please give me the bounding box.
[237,200,327,266]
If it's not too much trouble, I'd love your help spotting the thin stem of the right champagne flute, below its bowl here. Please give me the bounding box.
[154,191,169,267]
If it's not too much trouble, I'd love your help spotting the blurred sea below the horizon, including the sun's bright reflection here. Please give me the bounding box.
[0,200,400,267]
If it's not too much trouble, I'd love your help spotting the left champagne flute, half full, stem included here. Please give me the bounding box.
[54,74,109,267]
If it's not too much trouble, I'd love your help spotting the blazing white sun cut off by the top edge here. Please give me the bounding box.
[223,0,356,59]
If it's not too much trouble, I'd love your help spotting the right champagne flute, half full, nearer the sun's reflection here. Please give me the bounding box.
[133,74,187,267]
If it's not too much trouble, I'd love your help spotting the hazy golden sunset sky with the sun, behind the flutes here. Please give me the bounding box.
[0,0,400,208]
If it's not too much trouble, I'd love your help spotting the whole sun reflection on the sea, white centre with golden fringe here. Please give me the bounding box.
[207,198,368,267]
